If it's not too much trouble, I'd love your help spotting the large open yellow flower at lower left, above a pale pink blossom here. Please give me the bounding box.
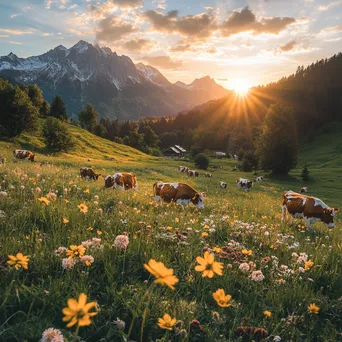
[62,293,97,328]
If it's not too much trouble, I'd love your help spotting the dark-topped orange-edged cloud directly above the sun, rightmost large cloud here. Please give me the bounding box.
[220,7,296,37]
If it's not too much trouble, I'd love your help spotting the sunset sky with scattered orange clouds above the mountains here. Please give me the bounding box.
[0,0,342,88]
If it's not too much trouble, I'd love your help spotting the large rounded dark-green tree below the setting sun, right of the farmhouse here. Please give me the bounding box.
[257,103,298,174]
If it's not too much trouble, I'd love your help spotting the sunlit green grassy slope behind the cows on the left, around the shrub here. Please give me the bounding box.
[0,121,153,163]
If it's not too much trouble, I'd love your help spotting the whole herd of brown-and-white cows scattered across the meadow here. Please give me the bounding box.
[13,150,339,228]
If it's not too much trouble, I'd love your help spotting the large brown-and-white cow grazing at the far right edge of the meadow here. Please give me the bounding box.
[282,191,339,228]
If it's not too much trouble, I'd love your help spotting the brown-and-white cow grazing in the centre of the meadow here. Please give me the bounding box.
[153,182,205,209]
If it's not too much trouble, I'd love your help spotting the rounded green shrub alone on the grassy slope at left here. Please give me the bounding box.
[43,117,75,152]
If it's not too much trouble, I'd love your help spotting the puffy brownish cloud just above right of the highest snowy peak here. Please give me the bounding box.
[96,15,137,42]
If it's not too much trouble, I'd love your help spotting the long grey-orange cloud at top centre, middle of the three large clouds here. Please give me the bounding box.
[143,10,216,38]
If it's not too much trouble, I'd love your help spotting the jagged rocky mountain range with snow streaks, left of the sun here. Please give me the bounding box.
[0,40,228,119]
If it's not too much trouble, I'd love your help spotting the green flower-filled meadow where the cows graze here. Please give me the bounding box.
[0,124,342,342]
